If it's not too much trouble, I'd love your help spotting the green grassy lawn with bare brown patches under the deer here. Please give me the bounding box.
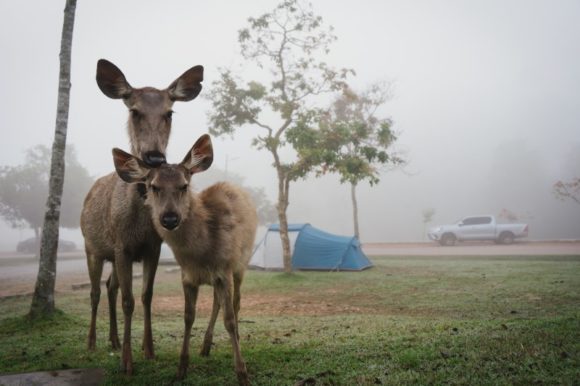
[0,256,580,385]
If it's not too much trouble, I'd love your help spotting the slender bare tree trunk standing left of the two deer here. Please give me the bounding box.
[29,0,76,318]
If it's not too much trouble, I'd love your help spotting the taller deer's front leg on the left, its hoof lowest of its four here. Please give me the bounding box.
[115,254,135,375]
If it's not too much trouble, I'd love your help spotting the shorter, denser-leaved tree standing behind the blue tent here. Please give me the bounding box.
[288,83,406,238]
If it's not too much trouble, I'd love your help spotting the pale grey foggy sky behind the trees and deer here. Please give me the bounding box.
[0,0,580,249]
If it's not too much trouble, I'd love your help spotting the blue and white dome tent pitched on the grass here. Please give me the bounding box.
[250,224,373,271]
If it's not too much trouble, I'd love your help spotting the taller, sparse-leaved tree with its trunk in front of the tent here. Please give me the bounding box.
[209,0,351,272]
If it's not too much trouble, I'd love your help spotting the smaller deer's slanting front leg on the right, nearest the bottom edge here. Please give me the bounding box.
[215,275,250,386]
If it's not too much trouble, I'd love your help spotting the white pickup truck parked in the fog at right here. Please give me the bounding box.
[428,216,528,246]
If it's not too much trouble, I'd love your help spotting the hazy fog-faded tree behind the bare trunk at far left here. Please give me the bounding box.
[0,145,93,229]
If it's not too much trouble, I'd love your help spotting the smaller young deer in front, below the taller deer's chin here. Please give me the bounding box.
[113,135,258,385]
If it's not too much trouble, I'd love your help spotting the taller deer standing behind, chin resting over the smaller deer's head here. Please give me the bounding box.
[81,59,203,374]
